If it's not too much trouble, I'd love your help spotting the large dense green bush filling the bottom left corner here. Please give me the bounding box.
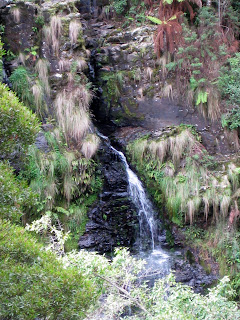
[0,221,96,320]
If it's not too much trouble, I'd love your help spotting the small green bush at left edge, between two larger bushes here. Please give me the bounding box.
[0,162,36,223]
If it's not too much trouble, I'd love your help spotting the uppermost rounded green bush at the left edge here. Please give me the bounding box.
[0,84,39,157]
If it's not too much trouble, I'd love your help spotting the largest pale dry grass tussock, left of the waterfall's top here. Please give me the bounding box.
[54,87,90,143]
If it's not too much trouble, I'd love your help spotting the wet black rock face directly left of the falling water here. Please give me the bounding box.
[79,145,137,253]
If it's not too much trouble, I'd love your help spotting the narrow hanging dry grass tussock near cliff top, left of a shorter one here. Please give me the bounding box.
[44,16,62,56]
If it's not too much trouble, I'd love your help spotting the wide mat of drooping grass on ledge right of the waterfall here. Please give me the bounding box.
[129,129,240,224]
